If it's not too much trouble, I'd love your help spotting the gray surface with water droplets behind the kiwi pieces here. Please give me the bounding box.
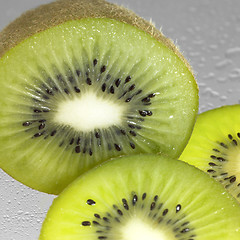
[0,0,240,240]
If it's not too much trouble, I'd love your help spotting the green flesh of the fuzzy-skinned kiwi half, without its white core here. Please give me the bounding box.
[0,19,198,194]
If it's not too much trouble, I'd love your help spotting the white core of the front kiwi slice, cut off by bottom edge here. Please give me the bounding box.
[121,218,175,240]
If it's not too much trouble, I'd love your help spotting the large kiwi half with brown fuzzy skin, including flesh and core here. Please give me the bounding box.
[0,0,198,194]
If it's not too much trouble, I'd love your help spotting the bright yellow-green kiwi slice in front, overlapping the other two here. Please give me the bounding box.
[40,154,240,240]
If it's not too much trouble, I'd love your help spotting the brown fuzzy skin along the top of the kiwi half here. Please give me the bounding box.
[0,0,193,74]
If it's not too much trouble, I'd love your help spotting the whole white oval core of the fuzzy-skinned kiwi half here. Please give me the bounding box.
[55,92,125,132]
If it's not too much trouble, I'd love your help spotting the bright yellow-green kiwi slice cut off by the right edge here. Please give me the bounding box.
[180,105,240,202]
